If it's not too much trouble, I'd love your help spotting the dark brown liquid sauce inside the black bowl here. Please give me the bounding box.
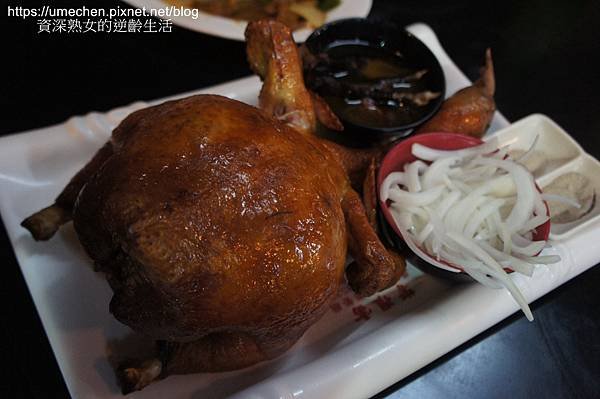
[305,40,443,129]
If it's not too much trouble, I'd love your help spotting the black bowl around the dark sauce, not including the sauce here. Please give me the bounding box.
[305,18,446,141]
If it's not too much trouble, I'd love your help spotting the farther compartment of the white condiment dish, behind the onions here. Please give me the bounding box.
[486,114,584,179]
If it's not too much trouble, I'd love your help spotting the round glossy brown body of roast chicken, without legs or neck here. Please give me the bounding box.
[73,96,349,344]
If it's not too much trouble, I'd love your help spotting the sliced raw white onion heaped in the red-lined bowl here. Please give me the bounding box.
[380,139,560,320]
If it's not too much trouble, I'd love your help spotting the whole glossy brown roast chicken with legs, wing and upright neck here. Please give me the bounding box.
[23,22,405,392]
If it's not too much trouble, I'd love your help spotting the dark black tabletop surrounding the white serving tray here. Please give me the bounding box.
[0,0,600,398]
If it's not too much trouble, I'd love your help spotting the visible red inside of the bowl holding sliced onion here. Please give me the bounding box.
[377,133,550,273]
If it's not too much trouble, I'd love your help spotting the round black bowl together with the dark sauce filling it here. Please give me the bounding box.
[303,19,445,134]
